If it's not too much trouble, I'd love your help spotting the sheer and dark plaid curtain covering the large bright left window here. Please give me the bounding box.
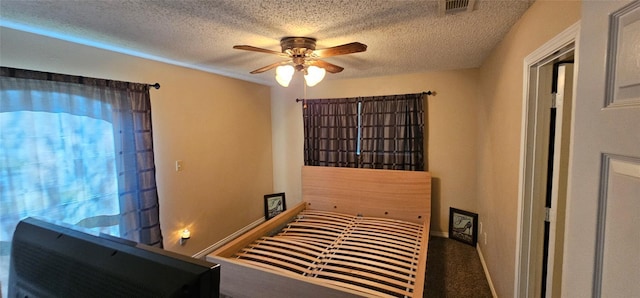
[0,67,162,247]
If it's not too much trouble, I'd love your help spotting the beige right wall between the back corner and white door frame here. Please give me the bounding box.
[476,0,580,297]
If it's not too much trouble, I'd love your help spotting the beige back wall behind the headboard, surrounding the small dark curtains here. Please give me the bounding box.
[271,69,478,233]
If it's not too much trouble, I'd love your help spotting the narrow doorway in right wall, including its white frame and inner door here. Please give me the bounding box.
[514,24,580,297]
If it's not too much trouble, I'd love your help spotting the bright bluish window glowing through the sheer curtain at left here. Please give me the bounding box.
[0,108,120,234]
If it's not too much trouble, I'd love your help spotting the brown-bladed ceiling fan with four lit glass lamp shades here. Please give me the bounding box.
[233,37,367,87]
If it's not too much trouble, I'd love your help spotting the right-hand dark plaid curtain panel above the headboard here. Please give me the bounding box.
[360,93,425,171]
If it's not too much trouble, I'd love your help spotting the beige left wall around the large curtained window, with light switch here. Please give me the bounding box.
[0,28,273,255]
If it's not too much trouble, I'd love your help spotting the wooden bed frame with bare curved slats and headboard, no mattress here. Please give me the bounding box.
[206,166,431,297]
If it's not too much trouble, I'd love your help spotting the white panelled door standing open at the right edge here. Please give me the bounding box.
[562,0,640,297]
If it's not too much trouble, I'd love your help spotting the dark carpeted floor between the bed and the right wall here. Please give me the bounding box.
[424,237,492,298]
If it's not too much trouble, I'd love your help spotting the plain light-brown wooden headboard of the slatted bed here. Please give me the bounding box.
[302,166,431,223]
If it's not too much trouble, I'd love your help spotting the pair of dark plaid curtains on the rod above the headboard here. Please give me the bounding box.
[303,93,425,171]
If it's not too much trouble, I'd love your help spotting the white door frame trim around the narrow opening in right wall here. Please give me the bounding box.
[514,21,580,297]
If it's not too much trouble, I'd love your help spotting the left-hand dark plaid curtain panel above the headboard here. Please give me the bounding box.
[302,98,358,168]
